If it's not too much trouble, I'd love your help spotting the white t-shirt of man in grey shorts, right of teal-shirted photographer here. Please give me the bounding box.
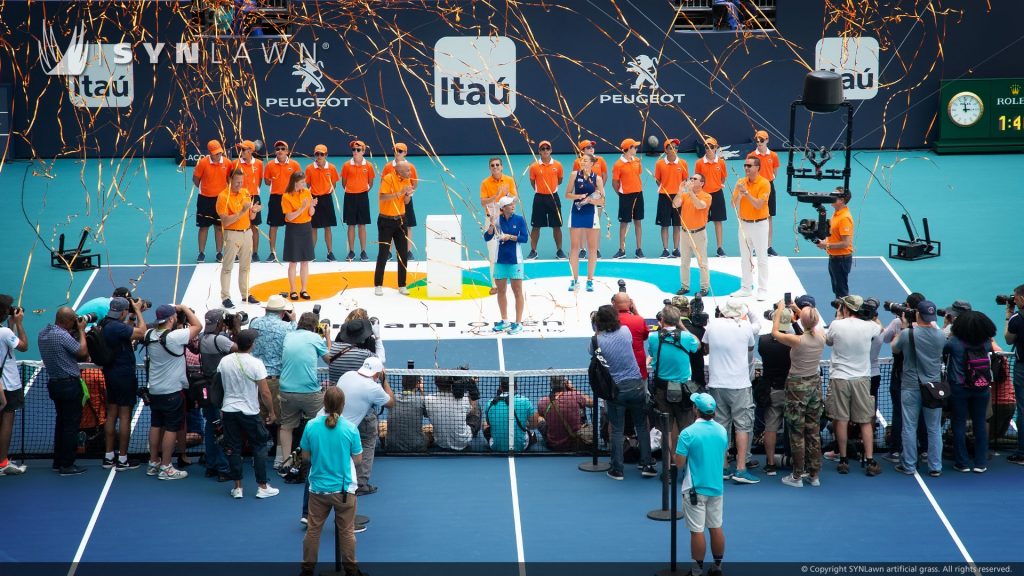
[703,318,755,389]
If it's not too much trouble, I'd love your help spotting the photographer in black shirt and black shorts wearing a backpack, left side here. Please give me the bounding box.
[98,296,146,471]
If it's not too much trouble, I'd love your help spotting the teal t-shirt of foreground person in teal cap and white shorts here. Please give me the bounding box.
[676,417,729,496]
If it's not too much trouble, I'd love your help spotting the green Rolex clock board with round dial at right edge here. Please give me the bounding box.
[935,78,1024,154]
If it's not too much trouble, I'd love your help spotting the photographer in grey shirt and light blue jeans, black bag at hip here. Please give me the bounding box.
[893,300,946,477]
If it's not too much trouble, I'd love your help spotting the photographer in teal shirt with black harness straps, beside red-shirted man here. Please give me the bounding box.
[647,305,700,453]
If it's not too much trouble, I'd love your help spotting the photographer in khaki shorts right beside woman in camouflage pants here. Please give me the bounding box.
[825,294,882,476]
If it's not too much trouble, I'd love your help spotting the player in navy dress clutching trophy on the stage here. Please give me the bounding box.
[565,153,604,292]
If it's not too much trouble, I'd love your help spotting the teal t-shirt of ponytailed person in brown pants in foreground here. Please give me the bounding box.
[299,414,362,494]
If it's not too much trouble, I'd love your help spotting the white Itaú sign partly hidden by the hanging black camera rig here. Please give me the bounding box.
[814,36,880,100]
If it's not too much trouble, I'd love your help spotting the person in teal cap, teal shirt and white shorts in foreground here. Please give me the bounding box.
[676,394,729,576]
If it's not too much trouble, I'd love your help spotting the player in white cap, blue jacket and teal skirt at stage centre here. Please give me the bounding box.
[483,196,529,334]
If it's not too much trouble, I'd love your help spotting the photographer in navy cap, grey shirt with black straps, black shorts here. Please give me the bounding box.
[142,304,203,480]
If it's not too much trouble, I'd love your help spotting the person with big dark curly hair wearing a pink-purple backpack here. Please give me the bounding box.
[942,311,995,474]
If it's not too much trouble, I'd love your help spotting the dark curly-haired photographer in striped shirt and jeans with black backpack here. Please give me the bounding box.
[590,304,657,480]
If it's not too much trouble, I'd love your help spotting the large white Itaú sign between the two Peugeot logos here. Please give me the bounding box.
[434,36,516,118]
